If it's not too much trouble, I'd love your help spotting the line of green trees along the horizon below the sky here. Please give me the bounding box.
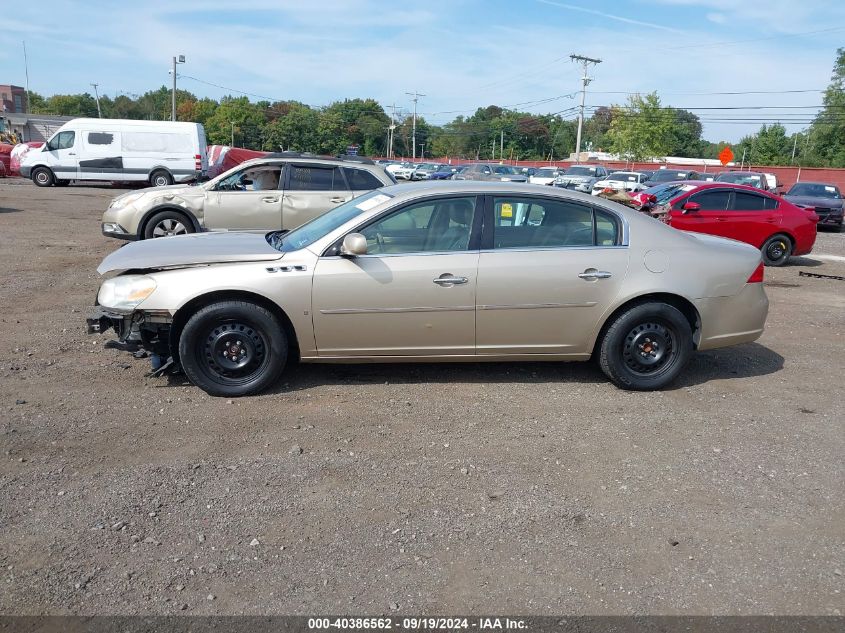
[23,49,845,167]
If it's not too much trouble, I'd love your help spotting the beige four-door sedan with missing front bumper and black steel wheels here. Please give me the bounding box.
[88,181,768,397]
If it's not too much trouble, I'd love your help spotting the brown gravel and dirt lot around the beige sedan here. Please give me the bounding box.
[0,180,845,614]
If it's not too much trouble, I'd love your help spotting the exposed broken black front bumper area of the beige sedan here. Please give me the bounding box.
[85,306,180,376]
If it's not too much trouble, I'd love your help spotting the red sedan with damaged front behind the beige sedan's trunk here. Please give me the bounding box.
[644,181,818,266]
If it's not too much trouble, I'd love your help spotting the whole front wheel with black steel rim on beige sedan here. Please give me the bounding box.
[179,301,288,398]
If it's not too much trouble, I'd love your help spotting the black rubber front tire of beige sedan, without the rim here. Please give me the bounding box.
[179,301,288,398]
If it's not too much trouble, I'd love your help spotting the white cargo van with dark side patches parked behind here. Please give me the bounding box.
[21,119,208,187]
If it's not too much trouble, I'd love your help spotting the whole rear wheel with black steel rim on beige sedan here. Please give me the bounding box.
[599,302,693,391]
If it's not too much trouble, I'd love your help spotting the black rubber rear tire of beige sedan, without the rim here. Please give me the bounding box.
[599,302,693,391]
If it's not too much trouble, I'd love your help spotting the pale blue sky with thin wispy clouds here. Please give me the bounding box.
[0,0,845,141]
